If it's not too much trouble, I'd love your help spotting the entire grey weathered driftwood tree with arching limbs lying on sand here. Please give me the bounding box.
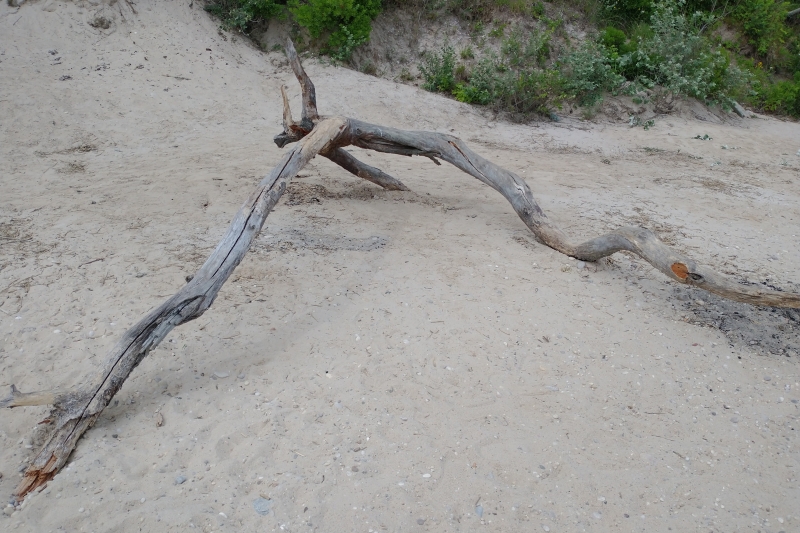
[0,41,800,500]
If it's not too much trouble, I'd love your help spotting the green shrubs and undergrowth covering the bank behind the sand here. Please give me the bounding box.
[206,0,800,118]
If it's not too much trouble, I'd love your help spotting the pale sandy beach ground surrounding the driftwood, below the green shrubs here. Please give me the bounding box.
[0,0,800,532]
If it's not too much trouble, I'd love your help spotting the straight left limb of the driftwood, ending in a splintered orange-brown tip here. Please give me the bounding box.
[4,118,347,499]
